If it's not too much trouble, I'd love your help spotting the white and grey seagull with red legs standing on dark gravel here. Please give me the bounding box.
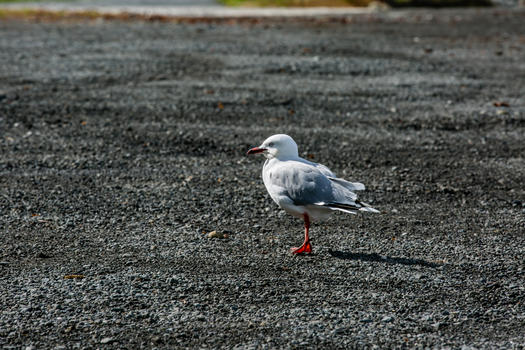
[247,134,379,254]
